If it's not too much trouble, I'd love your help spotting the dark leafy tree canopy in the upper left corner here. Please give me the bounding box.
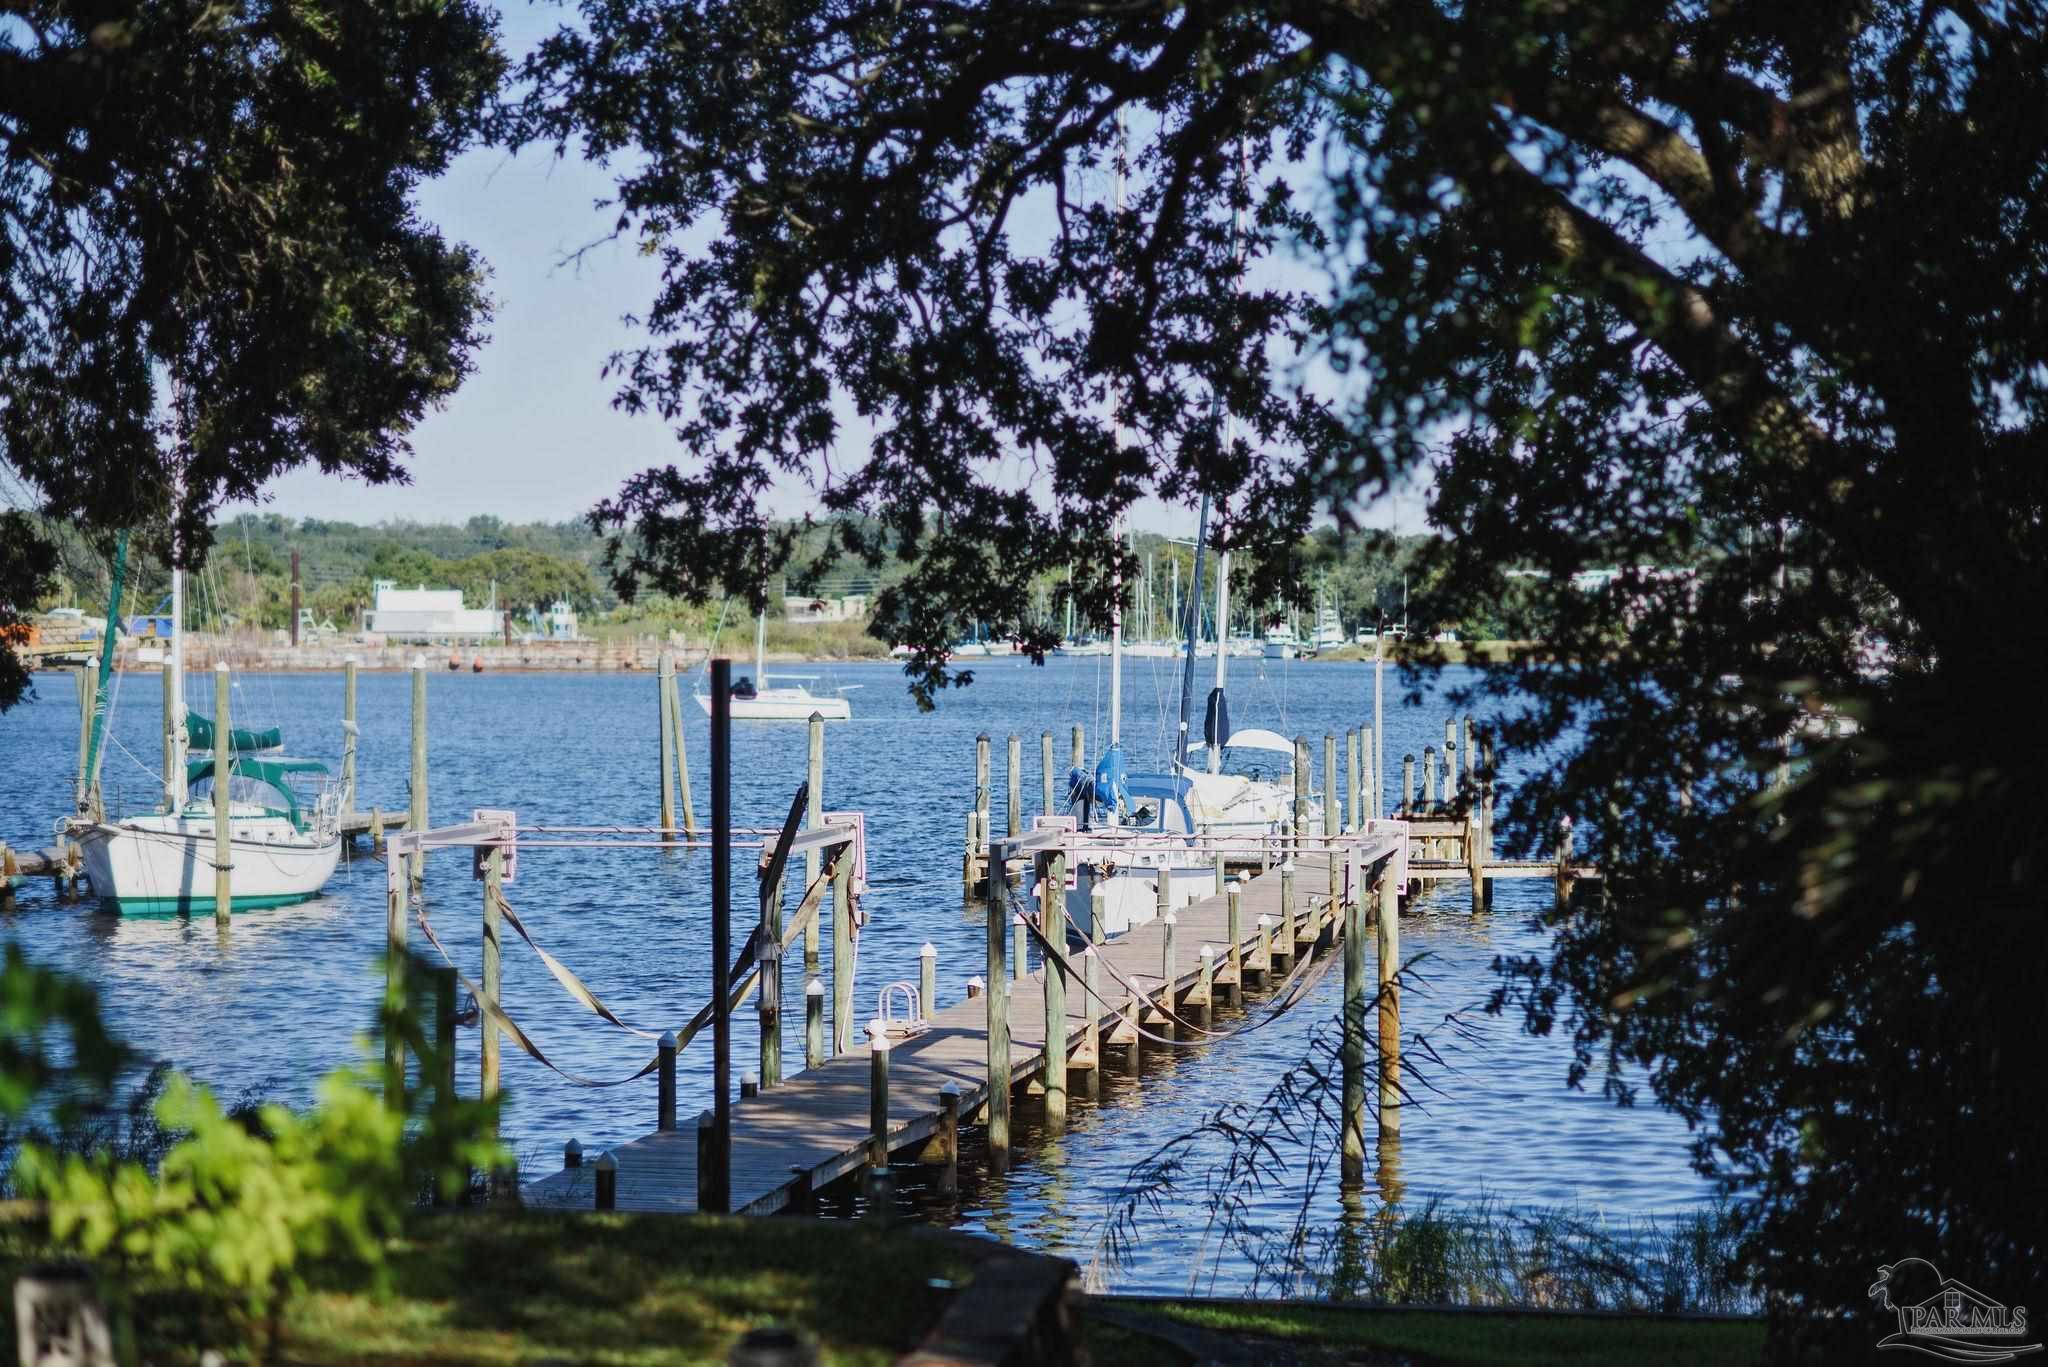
[0,0,506,705]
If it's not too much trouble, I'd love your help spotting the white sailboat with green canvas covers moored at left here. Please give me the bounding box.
[70,570,342,916]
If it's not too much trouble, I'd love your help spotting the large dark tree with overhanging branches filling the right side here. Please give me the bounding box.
[514,0,2048,1355]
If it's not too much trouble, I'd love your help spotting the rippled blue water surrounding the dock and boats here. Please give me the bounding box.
[0,660,1710,1289]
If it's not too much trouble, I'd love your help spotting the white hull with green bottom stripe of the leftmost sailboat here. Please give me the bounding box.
[78,818,342,916]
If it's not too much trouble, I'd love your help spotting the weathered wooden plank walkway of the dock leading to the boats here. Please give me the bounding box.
[524,855,1384,1215]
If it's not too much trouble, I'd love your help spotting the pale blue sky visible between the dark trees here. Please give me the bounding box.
[266,4,1421,533]
